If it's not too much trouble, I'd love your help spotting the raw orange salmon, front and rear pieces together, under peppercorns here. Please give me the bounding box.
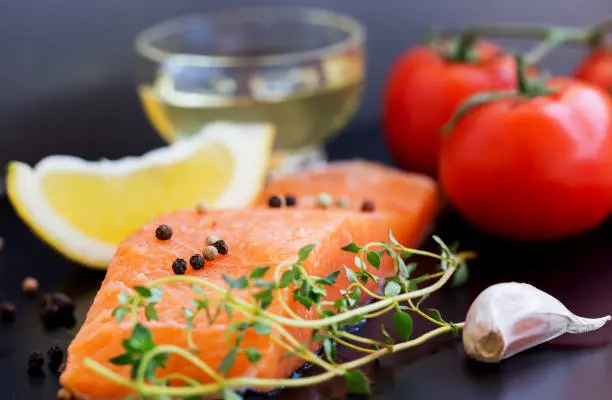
[61,162,439,399]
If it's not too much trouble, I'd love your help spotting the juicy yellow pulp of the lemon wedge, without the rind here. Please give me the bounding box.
[42,145,234,243]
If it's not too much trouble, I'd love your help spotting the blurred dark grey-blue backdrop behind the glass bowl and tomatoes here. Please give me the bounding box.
[0,0,612,165]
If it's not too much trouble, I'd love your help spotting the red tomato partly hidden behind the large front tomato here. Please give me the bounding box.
[382,42,516,176]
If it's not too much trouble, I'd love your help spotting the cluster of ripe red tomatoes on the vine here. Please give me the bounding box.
[382,23,612,240]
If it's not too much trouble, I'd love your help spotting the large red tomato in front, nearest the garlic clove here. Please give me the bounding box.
[440,78,612,240]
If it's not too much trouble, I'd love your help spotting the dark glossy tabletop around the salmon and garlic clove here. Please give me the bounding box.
[0,176,612,400]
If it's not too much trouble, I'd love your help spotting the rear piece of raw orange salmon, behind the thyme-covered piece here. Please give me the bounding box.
[258,161,440,245]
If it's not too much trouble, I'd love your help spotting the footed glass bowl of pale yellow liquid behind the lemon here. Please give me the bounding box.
[136,7,365,171]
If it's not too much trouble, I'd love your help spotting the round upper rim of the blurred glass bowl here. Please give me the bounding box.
[134,6,365,67]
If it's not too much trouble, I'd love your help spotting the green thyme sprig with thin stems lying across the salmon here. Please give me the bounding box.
[84,232,471,400]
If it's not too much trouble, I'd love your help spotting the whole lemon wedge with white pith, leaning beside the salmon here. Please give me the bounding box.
[6,122,274,268]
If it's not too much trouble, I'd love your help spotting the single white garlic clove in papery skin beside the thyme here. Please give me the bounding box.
[463,282,610,363]
